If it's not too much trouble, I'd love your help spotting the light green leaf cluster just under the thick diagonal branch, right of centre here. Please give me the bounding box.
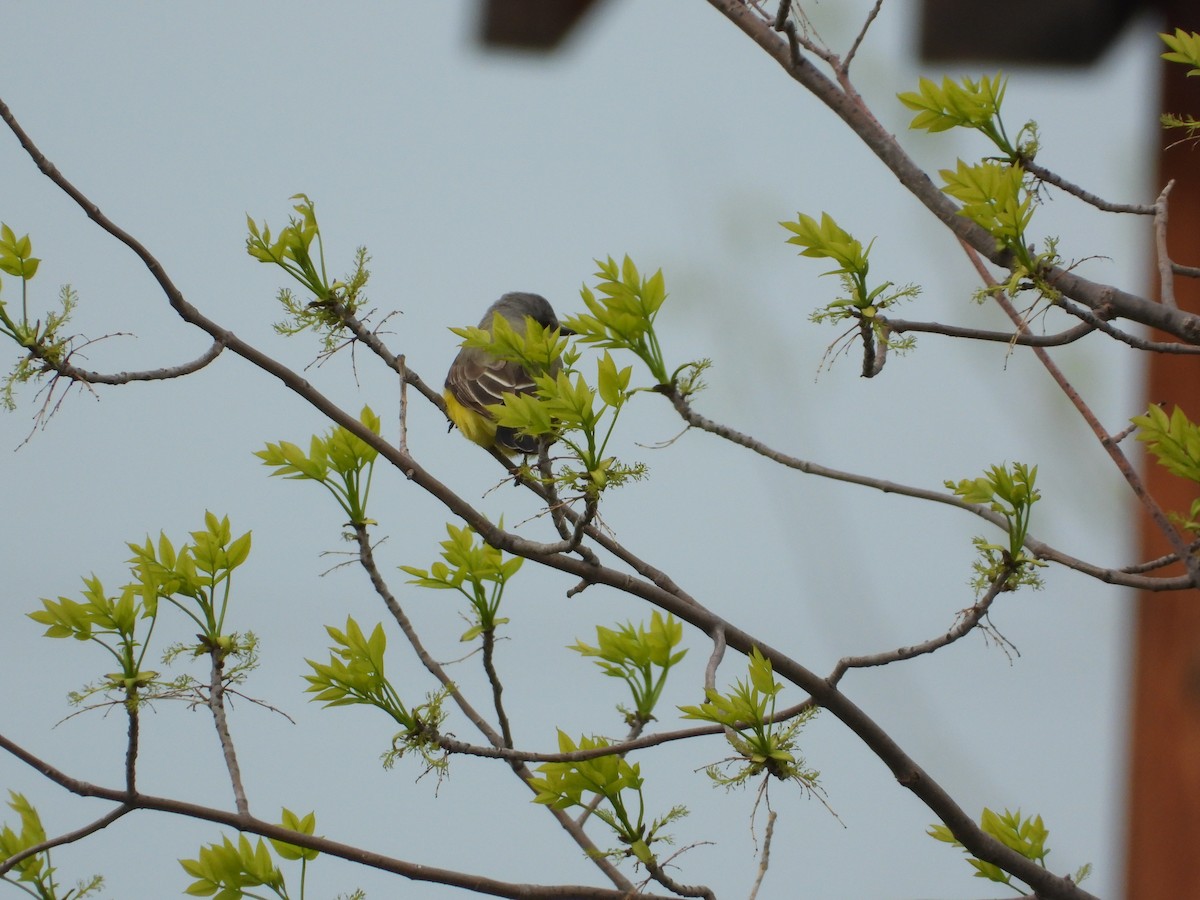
[679,647,820,788]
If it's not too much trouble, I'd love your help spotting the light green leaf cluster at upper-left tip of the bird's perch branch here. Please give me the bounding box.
[246,193,371,353]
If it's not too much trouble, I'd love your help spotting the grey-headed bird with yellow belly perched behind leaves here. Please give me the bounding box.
[442,292,575,455]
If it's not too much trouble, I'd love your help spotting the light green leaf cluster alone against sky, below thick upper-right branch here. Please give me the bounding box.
[780,212,920,353]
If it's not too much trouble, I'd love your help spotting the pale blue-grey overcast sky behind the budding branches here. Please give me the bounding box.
[0,0,1158,899]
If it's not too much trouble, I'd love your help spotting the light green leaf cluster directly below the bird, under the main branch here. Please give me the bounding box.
[400,522,524,641]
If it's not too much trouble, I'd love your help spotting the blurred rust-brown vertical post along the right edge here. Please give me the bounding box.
[1128,2,1200,900]
